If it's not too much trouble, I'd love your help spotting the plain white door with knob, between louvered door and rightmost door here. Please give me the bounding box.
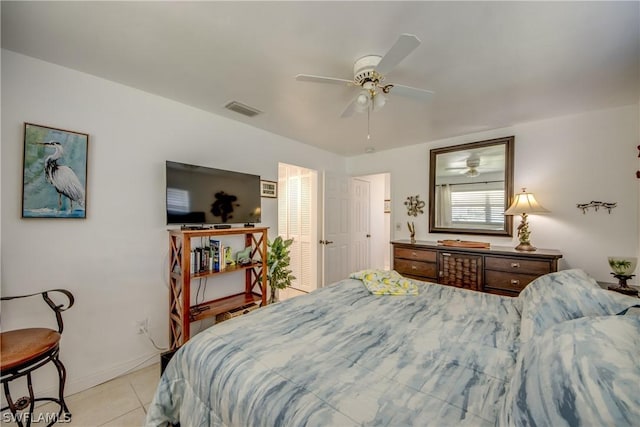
[319,172,351,286]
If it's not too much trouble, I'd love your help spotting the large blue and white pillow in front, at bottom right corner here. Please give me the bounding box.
[497,315,640,427]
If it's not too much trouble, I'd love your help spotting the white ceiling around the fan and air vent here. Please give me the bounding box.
[1,1,640,156]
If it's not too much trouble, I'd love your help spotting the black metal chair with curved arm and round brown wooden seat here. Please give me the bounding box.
[0,289,74,427]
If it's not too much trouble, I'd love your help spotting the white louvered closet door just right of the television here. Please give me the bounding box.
[278,163,318,292]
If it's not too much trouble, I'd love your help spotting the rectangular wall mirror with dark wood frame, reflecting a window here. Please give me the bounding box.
[429,136,514,236]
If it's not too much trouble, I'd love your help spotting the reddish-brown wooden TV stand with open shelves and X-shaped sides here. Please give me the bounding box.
[169,227,268,350]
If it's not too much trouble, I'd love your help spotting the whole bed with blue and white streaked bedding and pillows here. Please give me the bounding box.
[146,270,640,427]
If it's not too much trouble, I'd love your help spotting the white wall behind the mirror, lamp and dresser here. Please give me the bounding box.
[347,105,640,283]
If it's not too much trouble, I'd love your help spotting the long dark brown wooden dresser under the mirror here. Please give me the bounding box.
[391,240,562,296]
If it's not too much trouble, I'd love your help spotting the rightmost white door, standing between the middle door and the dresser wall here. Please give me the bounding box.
[351,178,371,271]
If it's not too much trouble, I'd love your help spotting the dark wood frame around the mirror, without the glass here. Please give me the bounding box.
[429,136,515,236]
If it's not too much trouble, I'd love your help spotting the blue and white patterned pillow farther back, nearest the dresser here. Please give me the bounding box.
[518,269,638,343]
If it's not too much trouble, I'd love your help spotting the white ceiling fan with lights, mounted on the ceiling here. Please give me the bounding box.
[296,34,433,118]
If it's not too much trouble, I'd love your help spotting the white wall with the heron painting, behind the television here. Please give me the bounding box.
[0,50,345,393]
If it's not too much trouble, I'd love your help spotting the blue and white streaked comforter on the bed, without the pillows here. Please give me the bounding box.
[146,279,520,427]
